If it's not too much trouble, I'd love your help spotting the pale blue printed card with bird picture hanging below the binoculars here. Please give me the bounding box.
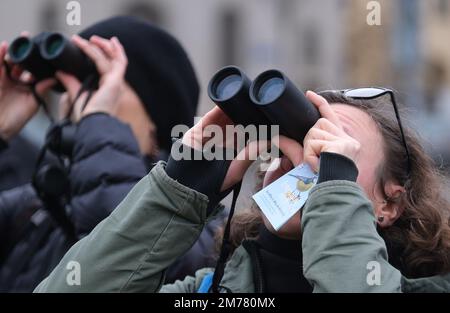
[253,164,319,230]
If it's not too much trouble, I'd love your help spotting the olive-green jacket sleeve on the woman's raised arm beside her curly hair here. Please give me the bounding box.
[302,181,402,292]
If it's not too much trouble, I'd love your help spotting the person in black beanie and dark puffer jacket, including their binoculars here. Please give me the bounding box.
[0,17,199,292]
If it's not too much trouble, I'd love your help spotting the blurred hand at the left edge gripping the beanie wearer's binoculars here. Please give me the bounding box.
[0,42,55,140]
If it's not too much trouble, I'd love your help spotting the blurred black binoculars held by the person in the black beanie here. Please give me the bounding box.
[8,32,98,91]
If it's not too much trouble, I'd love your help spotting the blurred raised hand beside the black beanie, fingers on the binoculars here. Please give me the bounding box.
[56,35,128,122]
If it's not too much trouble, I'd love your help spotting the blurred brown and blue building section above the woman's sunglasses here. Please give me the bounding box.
[345,0,423,107]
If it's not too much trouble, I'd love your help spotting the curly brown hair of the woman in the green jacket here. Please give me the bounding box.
[219,92,450,278]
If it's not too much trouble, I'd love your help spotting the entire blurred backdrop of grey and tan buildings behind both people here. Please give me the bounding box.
[0,0,450,172]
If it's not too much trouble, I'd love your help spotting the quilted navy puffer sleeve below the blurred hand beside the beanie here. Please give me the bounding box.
[70,113,147,236]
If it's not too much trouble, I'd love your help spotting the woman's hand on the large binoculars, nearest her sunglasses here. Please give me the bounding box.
[303,91,361,172]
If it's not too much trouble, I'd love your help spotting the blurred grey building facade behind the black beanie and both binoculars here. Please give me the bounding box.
[0,0,345,136]
